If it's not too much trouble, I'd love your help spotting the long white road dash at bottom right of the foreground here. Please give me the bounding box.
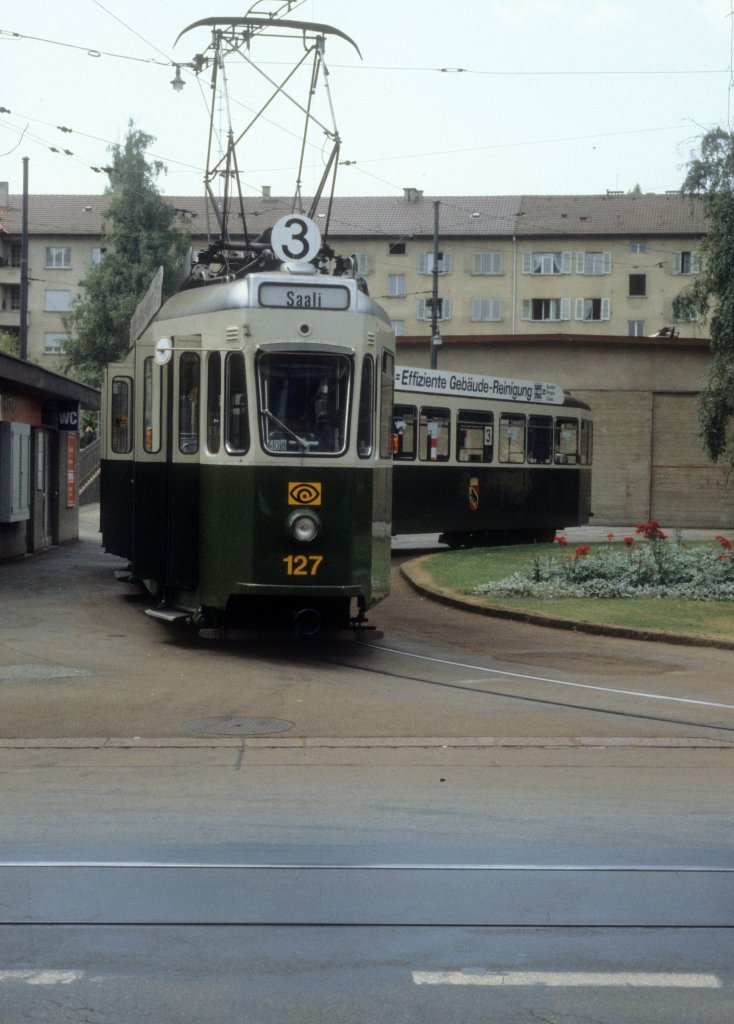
[413,970,722,988]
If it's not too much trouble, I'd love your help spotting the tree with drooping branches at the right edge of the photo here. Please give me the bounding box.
[674,128,734,467]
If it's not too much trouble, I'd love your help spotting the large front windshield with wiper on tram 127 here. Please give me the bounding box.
[258,352,352,456]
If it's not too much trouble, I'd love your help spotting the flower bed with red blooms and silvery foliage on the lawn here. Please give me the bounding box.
[474,519,734,601]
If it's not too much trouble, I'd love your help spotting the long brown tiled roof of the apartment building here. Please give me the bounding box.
[0,189,706,241]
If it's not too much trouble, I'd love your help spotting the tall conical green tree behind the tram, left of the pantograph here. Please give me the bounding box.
[62,122,189,387]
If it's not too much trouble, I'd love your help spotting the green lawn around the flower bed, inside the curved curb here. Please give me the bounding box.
[411,544,734,642]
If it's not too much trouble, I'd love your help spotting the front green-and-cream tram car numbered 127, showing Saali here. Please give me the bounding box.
[101,225,394,636]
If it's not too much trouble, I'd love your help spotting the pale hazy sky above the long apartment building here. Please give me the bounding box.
[0,0,734,196]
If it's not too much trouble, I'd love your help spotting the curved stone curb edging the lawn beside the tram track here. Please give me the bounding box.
[400,553,734,650]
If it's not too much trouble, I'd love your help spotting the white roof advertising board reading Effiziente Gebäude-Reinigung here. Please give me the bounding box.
[395,367,564,406]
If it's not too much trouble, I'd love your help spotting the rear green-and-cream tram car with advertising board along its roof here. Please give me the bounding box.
[392,367,593,547]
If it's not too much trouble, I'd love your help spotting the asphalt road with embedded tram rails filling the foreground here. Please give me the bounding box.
[0,510,734,1024]
